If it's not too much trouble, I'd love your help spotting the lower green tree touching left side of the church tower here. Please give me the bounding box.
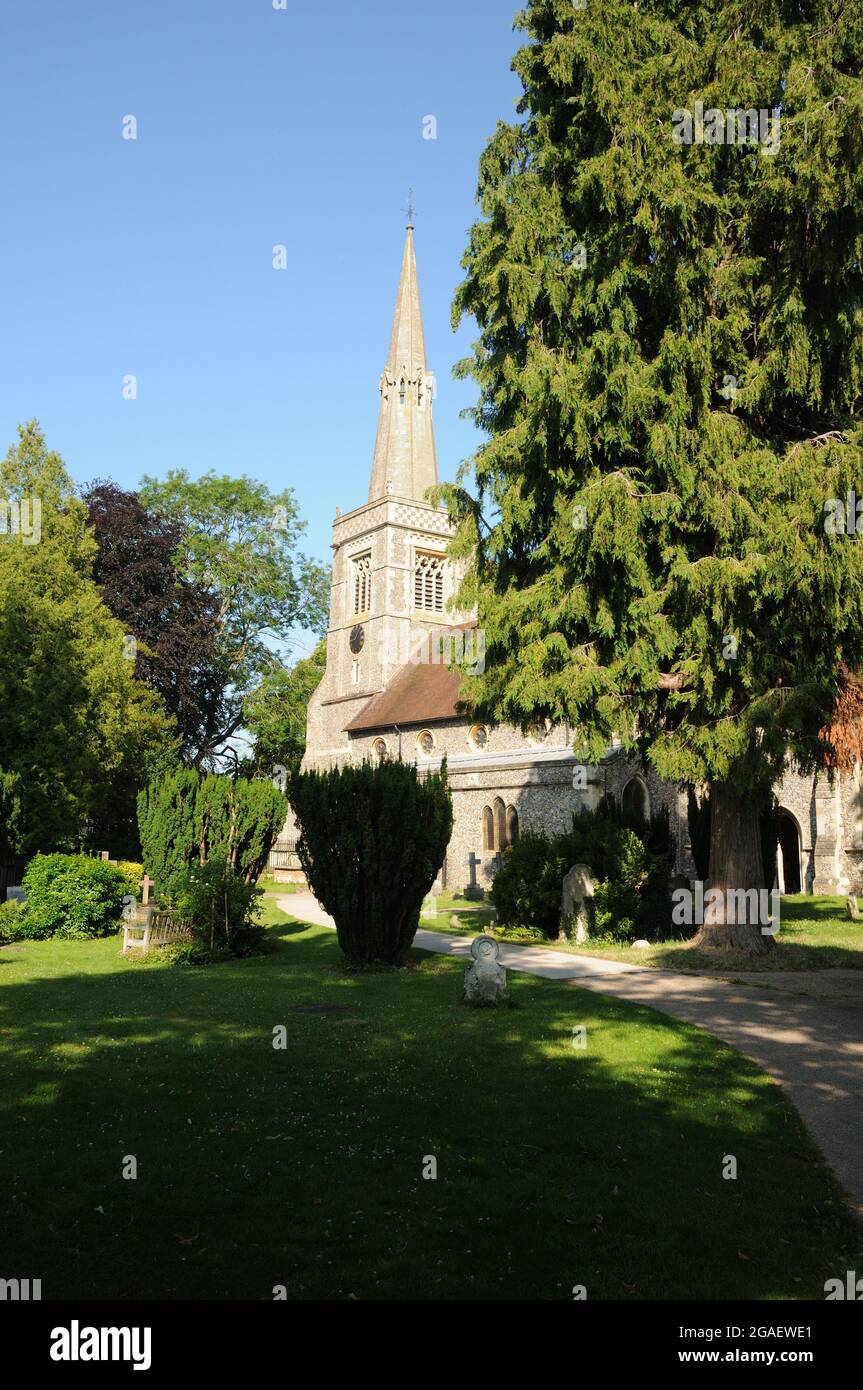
[243,641,327,771]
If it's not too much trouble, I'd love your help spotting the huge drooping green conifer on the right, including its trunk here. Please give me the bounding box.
[446,0,863,951]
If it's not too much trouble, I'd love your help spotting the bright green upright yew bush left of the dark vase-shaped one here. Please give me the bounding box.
[138,769,288,897]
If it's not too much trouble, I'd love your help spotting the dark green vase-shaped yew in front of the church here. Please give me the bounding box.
[288,760,453,966]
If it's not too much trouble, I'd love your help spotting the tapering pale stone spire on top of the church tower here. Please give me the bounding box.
[368,221,438,502]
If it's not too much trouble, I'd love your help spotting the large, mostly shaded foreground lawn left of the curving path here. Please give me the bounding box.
[0,902,863,1300]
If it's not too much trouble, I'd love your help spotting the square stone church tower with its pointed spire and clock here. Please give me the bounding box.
[306,214,460,767]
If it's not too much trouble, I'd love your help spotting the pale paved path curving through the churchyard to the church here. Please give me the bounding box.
[278,892,863,1215]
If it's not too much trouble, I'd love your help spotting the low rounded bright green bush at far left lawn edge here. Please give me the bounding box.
[22,855,126,941]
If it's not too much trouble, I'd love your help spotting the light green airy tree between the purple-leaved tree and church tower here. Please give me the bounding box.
[139,470,329,767]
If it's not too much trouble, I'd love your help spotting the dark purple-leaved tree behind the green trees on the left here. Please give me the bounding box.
[83,481,225,762]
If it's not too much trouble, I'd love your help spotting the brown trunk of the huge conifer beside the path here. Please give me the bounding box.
[695,783,775,955]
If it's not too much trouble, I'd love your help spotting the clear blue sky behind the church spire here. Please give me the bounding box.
[0,0,521,636]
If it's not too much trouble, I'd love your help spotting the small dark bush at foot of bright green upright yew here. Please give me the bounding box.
[175,859,263,956]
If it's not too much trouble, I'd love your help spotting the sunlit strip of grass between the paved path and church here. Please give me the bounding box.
[422,894,863,974]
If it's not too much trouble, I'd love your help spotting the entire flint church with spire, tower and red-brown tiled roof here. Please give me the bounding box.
[279,211,863,894]
